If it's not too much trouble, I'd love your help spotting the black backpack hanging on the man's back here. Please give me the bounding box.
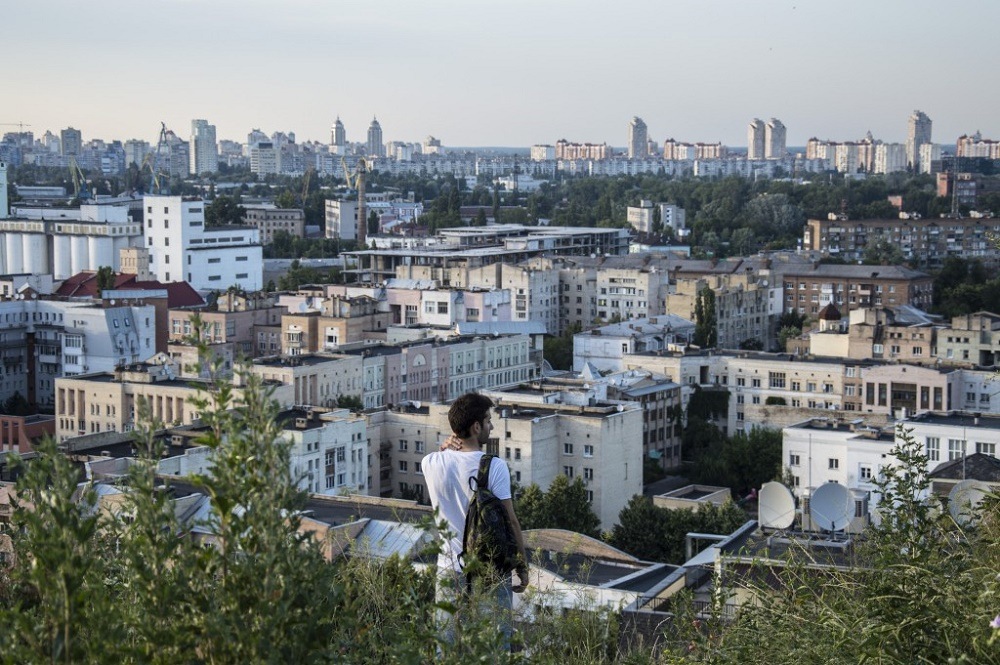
[459,455,520,576]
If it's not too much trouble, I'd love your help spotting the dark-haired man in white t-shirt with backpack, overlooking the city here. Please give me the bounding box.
[422,393,528,645]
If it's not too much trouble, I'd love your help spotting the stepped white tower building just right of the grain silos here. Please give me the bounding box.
[143,196,263,291]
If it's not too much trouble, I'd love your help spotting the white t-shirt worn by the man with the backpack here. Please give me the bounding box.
[421,450,511,571]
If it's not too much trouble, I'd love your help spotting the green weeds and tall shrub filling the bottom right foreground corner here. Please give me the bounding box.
[685,429,1000,663]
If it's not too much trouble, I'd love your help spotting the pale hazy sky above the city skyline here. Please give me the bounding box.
[7,0,1000,146]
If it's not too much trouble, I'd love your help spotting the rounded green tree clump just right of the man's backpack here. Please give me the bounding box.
[514,474,601,537]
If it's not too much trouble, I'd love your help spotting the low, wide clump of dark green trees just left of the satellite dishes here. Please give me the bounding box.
[608,495,747,564]
